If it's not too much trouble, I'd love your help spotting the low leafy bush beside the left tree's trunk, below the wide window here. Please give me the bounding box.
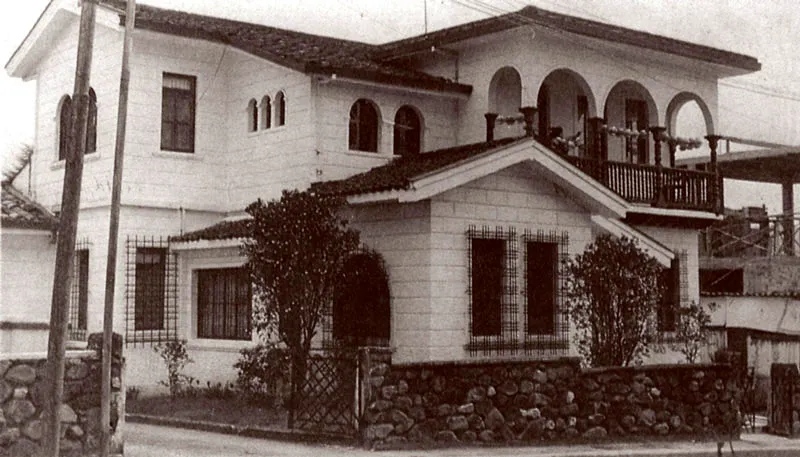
[233,344,290,406]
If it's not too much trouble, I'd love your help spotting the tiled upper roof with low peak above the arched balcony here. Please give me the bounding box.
[373,6,761,72]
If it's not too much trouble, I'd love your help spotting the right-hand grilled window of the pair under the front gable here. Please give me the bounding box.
[522,230,569,357]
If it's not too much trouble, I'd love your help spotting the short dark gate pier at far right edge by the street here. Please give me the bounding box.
[769,363,800,436]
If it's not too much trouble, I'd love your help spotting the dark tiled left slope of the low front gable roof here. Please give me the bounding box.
[312,138,520,196]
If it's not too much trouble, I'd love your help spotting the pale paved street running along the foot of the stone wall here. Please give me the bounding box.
[125,423,800,457]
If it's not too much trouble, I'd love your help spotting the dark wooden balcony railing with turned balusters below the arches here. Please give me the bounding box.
[563,156,722,212]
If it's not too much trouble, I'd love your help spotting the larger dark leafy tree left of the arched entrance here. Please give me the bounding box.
[242,190,359,414]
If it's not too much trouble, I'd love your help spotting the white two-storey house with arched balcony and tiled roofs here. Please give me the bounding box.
[4,0,760,385]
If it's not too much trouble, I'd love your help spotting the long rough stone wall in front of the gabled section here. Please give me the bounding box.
[362,359,739,448]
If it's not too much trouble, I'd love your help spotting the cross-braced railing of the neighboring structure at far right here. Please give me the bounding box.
[700,216,800,257]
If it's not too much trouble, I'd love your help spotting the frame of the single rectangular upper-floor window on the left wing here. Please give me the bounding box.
[161,72,197,153]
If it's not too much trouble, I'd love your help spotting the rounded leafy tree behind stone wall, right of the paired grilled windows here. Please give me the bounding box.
[564,235,664,366]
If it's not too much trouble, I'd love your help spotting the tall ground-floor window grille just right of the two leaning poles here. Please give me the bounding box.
[125,236,178,347]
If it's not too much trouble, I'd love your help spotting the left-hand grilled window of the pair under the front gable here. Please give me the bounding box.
[467,225,519,355]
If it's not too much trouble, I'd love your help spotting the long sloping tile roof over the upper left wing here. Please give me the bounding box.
[102,0,472,94]
